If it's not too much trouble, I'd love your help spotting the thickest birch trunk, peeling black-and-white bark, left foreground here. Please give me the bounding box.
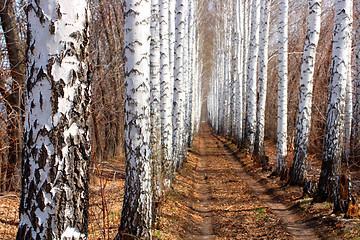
[17,0,90,239]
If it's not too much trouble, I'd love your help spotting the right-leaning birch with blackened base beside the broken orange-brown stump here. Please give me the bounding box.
[316,0,352,208]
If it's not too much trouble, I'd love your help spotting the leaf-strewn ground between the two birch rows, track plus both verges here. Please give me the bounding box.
[153,124,360,239]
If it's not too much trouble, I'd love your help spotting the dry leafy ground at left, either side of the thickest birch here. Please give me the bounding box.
[0,157,125,240]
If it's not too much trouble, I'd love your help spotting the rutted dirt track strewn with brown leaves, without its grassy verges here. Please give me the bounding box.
[185,124,319,239]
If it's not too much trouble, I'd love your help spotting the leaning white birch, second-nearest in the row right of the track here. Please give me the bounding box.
[289,0,321,185]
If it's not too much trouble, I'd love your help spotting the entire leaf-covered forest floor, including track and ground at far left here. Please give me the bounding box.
[0,124,360,240]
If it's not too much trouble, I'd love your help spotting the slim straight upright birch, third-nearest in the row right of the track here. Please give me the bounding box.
[274,0,289,177]
